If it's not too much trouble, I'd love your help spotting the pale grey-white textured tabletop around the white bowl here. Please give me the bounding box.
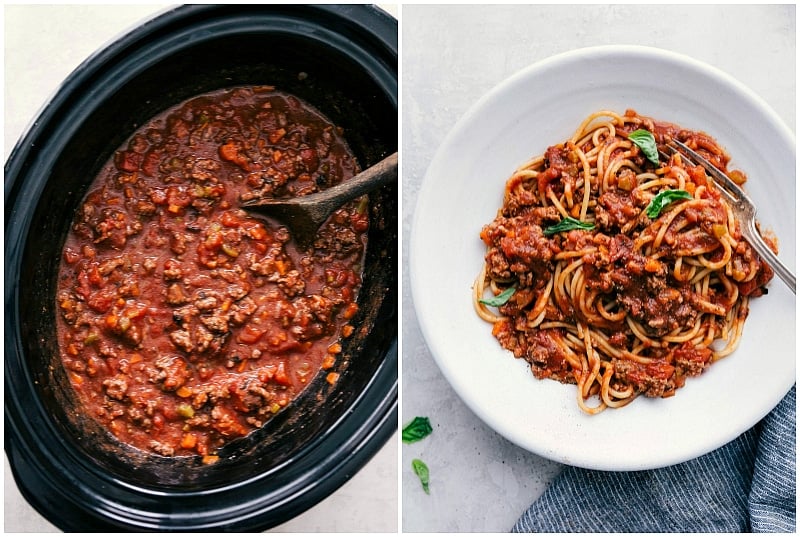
[401,5,796,532]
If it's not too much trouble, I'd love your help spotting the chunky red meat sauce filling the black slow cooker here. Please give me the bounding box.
[57,87,369,462]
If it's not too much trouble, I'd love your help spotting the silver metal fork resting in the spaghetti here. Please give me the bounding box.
[667,139,797,295]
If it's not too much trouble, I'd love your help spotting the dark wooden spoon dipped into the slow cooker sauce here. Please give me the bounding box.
[240,153,397,248]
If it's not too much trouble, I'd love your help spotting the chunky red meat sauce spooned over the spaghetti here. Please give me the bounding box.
[481,111,777,397]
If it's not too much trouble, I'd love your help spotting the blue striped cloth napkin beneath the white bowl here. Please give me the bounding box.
[512,387,796,533]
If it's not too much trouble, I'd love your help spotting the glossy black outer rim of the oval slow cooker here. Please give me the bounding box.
[4,5,398,530]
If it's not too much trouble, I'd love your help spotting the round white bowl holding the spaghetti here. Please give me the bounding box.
[410,46,796,470]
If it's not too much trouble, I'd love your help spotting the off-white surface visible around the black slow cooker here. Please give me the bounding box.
[3,5,398,532]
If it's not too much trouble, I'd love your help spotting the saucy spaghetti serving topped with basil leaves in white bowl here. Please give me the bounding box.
[473,110,777,414]
